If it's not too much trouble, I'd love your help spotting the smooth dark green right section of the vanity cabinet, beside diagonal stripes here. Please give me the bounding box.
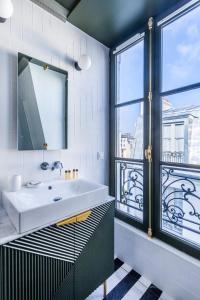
[75,202,114,300]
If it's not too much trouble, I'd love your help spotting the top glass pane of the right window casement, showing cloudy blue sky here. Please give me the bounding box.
[162,6,200,91]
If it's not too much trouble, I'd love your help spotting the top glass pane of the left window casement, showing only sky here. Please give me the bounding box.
[117,40,144,103]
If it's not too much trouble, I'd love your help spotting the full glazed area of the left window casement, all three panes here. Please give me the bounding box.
[114,38,144,223]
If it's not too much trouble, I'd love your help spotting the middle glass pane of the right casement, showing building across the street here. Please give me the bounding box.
[162,89,200,164]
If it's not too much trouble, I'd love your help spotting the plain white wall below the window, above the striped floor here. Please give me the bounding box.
[115,219,200,300]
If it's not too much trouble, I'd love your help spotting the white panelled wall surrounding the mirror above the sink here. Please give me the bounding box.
[0,0,109,195]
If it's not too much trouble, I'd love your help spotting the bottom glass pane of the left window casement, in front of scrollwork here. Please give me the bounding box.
[116,161,143,221]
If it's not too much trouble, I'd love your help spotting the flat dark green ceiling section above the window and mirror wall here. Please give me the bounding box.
[57,0,184,47]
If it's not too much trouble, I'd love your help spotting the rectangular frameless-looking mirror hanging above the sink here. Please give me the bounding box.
[18,53,68,150]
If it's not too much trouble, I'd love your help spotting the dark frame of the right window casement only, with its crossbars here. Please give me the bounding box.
[153,2,200,259]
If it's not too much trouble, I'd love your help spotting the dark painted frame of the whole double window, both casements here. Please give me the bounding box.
[110,0,200,259]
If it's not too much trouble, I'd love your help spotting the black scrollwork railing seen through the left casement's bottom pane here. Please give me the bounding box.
[120,162,143,211]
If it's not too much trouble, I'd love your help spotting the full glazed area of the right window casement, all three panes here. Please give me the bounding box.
[160,7,200,250]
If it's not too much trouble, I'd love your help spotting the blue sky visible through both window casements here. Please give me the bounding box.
[118,6,200,132]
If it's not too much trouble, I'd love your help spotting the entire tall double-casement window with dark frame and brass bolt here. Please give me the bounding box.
[111,1,200,258]
